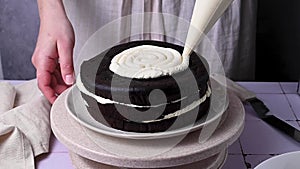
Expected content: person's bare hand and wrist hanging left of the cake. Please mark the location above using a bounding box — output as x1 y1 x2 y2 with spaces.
32 0 75 103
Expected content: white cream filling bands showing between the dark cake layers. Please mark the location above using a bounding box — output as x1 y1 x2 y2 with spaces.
76 74 211 123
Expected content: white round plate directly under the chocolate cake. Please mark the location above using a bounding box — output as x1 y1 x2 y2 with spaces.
65 79 229 139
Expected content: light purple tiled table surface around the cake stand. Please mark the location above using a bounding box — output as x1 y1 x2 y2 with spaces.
6 81 300 169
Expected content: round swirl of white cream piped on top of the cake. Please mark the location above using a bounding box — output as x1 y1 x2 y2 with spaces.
109 45 189 79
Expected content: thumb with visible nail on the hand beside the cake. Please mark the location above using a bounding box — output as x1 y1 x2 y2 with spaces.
57 39 75 85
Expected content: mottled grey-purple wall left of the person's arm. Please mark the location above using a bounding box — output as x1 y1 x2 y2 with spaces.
0 0 39 80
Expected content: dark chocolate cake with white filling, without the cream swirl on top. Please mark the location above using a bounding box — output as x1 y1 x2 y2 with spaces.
76 41 211 132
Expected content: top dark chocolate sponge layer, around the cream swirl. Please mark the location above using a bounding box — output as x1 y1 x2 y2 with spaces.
80 41 209 106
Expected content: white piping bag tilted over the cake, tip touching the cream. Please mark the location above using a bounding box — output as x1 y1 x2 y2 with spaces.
182 0 233 57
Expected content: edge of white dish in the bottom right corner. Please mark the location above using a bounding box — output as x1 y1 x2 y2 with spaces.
254 151 300 169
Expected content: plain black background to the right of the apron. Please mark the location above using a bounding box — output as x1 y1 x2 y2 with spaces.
255 0 300 81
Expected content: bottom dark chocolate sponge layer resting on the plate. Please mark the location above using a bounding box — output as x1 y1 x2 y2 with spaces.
82 94 210 133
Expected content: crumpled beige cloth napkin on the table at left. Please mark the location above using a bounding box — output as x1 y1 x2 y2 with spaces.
0 79 51 169
